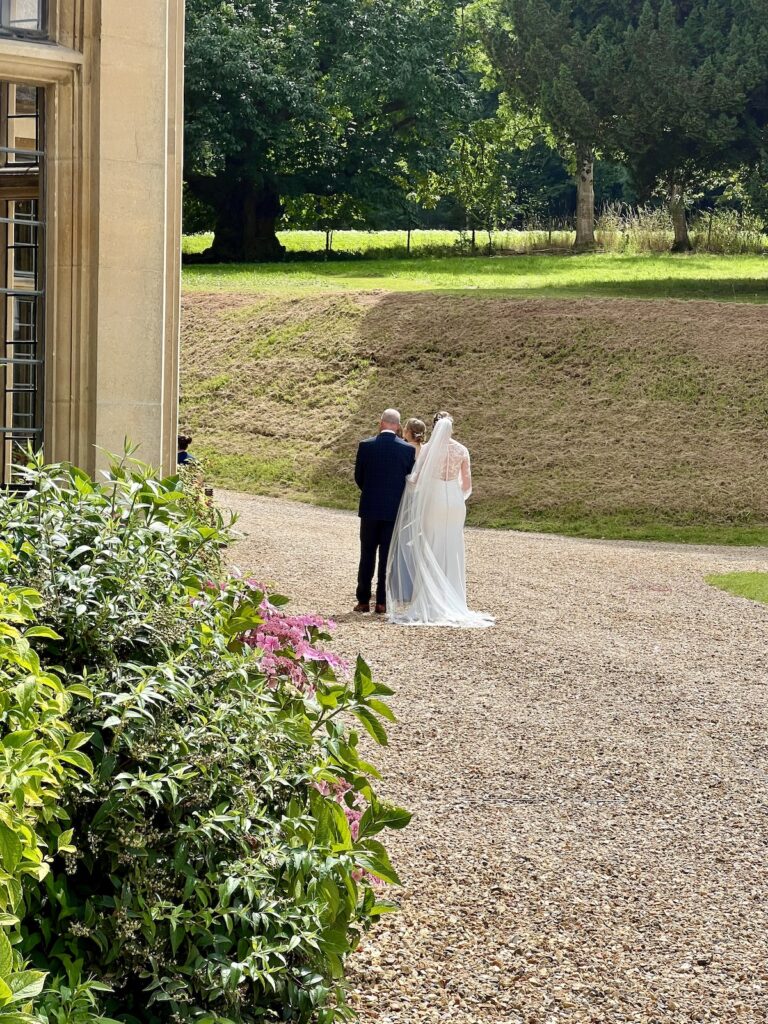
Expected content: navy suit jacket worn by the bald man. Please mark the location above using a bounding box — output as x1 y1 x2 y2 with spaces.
354 433 416 522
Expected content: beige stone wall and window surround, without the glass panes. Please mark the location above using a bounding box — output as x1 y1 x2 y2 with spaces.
0 0 183 470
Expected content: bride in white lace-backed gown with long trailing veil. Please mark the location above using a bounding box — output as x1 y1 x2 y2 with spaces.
387 413 494 629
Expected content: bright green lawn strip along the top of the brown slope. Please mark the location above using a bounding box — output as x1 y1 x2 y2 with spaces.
184 253 768 302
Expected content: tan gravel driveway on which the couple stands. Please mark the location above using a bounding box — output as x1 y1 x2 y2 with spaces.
224 494 768 1024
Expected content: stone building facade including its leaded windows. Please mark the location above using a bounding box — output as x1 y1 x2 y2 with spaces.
0 0 183 483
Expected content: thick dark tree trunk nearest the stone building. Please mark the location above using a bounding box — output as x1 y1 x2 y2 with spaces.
190 178 286 263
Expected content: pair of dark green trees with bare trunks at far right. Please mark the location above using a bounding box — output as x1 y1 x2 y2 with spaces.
484 0 768 249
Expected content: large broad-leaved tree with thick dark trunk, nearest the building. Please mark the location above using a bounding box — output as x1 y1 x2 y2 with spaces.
185 0 470 260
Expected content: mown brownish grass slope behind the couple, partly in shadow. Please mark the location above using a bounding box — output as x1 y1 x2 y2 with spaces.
181 291 768 543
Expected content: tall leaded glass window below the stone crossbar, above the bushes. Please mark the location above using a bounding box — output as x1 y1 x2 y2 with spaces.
0 82 45 486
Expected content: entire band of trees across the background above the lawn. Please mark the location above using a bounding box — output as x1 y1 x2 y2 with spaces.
185 0 768 260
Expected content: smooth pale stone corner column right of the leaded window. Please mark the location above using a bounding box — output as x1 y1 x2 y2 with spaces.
91 0 183 471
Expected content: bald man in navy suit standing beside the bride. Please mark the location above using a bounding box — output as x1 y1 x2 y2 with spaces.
354 409 416 614
